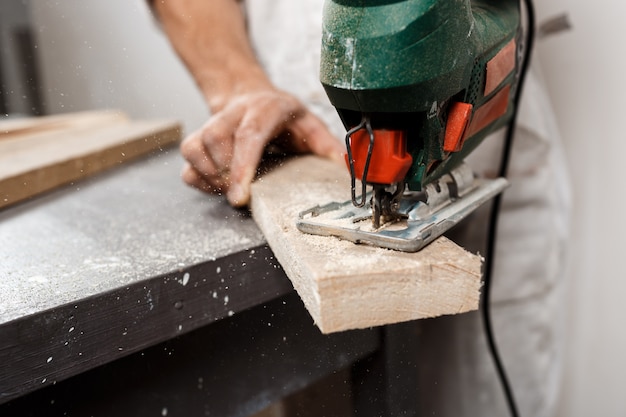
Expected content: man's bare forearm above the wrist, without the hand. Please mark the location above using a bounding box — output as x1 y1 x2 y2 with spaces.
154 0 270 112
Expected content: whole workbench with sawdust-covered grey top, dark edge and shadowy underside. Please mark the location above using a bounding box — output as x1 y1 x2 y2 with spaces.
0 148 417 417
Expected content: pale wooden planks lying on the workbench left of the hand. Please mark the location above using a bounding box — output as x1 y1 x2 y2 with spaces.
0 113 181 208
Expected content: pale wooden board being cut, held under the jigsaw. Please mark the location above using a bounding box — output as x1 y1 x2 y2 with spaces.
251 156 482 333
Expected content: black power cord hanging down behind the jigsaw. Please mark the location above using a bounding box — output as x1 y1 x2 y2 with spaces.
481 0 535 417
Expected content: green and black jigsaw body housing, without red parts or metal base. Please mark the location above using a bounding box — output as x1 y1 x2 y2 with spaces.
320 0 520 191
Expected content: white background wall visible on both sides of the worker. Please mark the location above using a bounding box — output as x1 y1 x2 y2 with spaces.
32 0 626 417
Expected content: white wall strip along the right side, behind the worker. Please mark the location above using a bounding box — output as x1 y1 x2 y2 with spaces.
536 0 626 417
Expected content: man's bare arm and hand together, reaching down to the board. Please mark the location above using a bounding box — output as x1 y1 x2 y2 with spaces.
154 0 343 206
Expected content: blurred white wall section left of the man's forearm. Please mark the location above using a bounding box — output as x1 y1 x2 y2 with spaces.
30 0 207 131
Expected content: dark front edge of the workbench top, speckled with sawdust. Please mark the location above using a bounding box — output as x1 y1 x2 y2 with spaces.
0 245 293 404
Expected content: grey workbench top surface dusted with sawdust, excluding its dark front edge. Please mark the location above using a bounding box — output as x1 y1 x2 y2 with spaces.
0 149 264 323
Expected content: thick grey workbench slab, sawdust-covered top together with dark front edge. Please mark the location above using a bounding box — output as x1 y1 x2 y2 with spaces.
0 148 293 403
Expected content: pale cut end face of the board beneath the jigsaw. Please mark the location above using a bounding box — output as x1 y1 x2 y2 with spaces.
318 244 482 333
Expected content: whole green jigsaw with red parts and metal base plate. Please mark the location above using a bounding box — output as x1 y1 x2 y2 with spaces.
297 0 521 252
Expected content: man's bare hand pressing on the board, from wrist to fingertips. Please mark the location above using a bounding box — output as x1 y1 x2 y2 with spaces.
181 89 343 207
